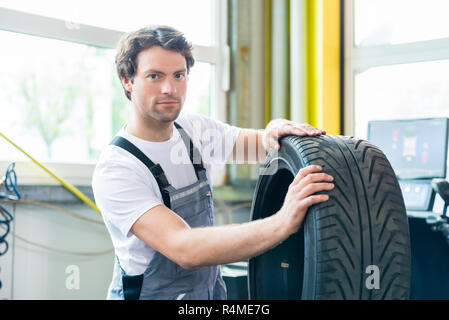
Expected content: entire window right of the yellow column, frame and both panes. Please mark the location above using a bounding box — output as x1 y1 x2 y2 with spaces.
344 0 449 138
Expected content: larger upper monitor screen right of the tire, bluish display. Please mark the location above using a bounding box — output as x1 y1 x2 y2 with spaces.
368 118 448 179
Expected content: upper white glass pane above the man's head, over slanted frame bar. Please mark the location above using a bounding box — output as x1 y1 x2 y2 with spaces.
0 0 213 46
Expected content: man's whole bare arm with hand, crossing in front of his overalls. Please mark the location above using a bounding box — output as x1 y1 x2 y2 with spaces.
131 166 333 269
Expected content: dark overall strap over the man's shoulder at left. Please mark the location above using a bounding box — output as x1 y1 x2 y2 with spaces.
110 136 170 208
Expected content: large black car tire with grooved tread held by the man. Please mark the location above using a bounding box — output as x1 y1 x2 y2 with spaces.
248 135 411 300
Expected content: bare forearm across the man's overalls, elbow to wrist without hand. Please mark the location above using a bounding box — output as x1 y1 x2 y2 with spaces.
173 216 287 268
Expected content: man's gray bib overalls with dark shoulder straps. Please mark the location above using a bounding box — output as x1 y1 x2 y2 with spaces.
108 122 226 300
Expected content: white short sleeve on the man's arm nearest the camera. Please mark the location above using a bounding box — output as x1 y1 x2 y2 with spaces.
92 160 163 237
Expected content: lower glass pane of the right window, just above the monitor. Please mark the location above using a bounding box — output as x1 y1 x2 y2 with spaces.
355 60 449 138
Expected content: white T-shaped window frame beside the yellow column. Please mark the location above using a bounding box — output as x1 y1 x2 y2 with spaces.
344 0 449 135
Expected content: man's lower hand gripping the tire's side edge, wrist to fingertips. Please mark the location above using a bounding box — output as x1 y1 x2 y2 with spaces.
277 165 334 237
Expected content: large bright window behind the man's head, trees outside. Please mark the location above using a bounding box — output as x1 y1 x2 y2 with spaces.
0 0 227 183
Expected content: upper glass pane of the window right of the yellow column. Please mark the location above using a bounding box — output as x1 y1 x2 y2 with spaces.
354 0 449 46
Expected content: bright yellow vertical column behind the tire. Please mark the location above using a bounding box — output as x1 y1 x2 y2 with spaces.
304 0 340 134
